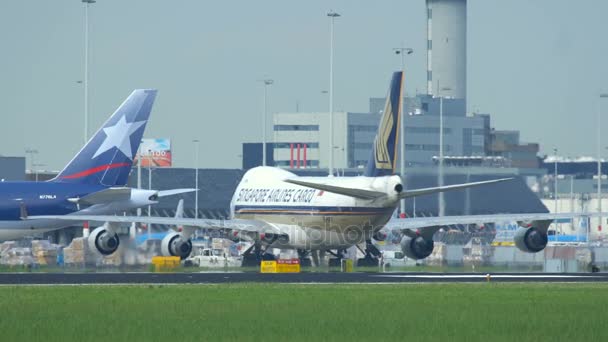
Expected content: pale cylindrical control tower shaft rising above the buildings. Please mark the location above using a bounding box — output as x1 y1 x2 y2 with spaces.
426 0 467 99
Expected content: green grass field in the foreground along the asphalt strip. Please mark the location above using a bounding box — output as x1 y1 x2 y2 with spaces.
0 283 608 342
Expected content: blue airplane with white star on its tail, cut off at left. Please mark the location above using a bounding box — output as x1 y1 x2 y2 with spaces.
0 89 194 254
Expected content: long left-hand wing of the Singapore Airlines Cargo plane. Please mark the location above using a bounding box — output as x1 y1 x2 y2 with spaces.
27 214 280 233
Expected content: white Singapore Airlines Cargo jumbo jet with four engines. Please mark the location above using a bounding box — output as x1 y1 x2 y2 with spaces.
32 72 592 264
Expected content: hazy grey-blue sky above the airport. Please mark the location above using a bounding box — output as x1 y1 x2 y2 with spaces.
0 0 608 169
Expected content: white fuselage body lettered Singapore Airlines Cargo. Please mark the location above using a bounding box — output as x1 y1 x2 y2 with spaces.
231 167 400 249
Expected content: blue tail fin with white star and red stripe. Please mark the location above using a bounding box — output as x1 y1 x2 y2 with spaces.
51 89 156 186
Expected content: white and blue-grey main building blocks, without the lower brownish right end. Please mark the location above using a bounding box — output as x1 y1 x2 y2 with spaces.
273 106 489 169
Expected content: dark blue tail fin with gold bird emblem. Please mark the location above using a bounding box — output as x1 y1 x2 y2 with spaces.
364 71 403 177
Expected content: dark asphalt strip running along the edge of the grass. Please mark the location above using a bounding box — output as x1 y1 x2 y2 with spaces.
0 272 608 285
